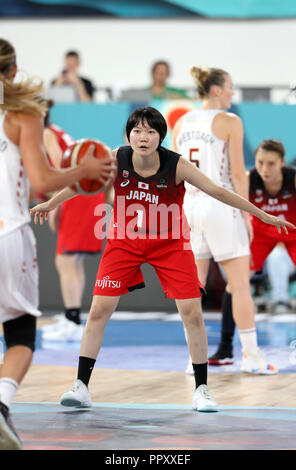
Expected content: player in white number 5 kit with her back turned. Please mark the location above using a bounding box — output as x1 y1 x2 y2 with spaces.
173 67 277 374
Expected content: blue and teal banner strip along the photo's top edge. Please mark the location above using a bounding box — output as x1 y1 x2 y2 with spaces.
0 0 296 18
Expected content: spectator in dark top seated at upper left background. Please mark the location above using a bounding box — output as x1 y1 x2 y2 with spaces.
51 51 95 102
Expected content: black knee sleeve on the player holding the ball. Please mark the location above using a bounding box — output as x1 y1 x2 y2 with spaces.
3 314 36 352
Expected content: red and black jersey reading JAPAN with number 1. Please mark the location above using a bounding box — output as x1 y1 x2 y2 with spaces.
108 146 190 239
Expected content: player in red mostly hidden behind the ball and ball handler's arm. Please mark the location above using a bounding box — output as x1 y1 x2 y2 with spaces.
42 101 105 341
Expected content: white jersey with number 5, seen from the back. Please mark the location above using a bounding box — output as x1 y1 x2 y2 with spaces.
176 109 234 194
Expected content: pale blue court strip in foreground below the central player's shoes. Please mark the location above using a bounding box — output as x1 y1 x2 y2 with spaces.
12 403 296 452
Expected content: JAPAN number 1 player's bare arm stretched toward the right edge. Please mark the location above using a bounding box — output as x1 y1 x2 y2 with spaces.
176 158 296 233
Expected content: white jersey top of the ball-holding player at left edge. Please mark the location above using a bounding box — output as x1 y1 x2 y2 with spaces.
0 114 30 237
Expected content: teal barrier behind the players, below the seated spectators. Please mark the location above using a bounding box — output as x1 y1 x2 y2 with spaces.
51 101 296 168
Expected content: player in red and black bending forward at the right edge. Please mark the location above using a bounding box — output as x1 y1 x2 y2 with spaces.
209 139 296 365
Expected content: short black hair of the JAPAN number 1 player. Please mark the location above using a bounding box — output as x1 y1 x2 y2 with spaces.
125 106 167 145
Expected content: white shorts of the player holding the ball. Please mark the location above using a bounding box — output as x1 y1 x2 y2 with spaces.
0 225 41 323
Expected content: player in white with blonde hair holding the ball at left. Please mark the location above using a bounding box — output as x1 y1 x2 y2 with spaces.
0 39 113 450
